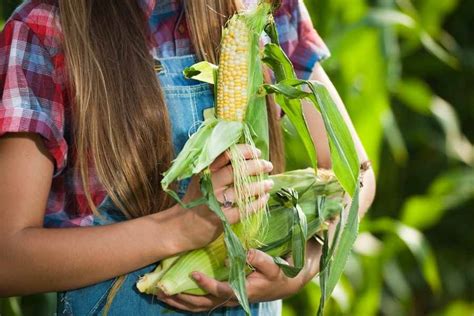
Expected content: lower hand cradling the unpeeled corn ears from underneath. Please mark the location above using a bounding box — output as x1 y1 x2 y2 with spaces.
158 241 321 312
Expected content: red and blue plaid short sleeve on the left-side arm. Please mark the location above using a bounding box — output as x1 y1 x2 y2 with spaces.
0 20 67 176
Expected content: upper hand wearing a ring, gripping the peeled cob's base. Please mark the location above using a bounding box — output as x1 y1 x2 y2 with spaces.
178 144 273 250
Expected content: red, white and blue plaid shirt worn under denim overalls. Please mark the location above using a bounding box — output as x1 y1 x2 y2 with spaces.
0 0 329 227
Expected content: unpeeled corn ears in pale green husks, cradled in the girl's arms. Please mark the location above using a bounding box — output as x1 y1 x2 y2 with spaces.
137 168 343 295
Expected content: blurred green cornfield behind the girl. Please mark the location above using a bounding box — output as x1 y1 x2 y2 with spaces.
0 0 474 316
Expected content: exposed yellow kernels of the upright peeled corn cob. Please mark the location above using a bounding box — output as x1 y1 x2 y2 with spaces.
217 16 249 122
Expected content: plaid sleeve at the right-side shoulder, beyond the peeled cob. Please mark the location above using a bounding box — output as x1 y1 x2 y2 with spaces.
275 0 331 79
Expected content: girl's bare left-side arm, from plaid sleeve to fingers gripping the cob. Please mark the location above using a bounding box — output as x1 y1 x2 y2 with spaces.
0 133 269 297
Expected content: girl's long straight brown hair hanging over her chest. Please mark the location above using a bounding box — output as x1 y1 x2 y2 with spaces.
59 0 284 218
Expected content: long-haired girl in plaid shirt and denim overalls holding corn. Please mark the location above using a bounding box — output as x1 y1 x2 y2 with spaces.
0 0 374 315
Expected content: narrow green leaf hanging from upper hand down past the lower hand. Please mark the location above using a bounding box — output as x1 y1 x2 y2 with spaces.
201 173 250 315
